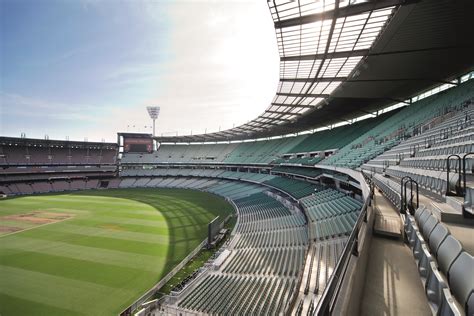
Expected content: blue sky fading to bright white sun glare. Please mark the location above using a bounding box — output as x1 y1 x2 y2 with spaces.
0 0 279 141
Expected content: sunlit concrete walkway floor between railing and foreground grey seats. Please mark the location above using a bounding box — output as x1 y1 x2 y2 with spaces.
360 236 431 316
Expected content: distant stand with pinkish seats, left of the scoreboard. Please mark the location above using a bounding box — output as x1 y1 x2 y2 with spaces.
0 137 118 195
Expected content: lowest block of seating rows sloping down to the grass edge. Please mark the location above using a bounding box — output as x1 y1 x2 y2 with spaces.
178 190 308 315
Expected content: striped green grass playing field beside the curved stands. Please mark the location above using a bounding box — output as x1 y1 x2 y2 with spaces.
0 189 232 316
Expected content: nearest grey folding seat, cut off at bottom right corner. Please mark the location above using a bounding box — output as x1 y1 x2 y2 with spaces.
449 251 474 315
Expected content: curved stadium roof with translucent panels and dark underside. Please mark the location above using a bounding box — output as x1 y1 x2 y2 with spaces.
156 0 474 142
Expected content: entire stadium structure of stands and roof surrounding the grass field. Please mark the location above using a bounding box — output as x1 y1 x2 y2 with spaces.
0 0 474 315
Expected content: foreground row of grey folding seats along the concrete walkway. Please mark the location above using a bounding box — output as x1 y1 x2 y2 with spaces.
404 206 474 315
